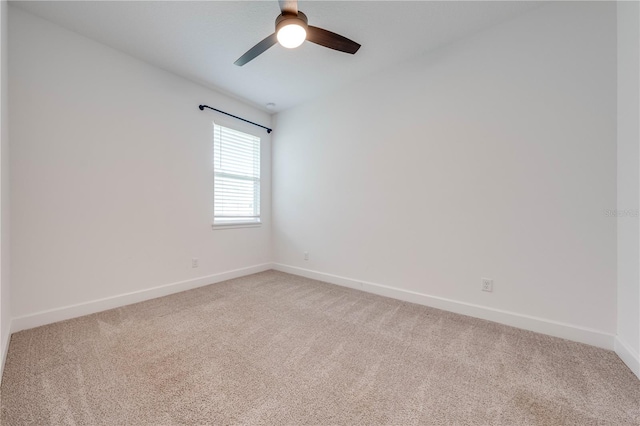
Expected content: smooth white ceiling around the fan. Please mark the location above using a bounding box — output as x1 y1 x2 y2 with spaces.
11 0 539 111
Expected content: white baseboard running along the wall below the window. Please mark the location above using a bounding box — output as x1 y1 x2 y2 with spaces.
7 263 272 332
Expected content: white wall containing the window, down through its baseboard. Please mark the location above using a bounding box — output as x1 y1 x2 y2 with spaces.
9 7 271 329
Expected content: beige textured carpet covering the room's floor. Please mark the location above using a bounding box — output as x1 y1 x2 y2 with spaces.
1 271 640 426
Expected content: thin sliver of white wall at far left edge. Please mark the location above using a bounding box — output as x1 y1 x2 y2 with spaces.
0 0 11 380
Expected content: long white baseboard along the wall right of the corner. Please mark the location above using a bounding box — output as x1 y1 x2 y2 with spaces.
273 263 615 350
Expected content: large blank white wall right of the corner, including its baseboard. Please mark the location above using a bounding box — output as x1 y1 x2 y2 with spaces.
273 2 616 348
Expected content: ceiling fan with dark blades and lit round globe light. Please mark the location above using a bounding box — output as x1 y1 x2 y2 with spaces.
234 0 360 67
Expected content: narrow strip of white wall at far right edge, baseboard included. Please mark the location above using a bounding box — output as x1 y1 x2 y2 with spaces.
616 2 640 376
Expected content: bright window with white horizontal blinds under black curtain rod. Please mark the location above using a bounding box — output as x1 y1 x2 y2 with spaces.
213 124 260 226
